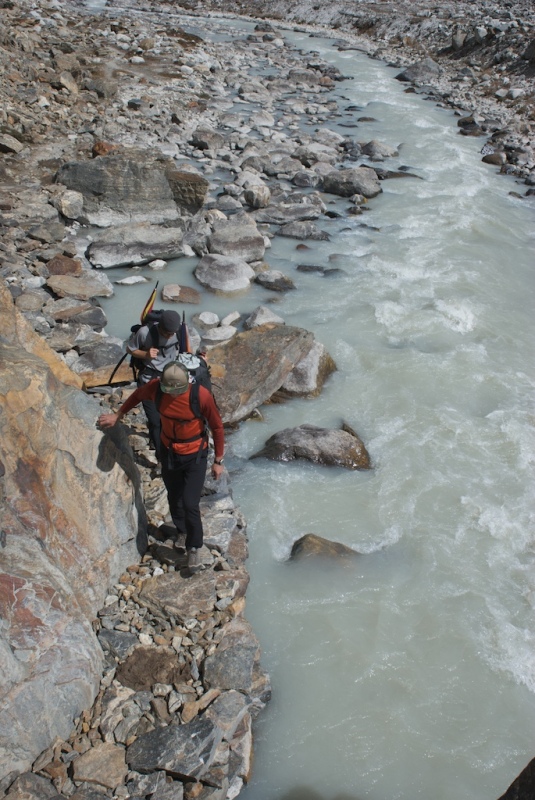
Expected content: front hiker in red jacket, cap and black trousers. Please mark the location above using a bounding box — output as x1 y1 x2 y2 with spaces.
98 362 225 573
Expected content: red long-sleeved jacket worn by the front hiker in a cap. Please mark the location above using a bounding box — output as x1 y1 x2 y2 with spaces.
121 378 225 458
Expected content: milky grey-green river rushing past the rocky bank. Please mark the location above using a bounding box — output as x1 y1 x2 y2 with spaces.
94 7 535 800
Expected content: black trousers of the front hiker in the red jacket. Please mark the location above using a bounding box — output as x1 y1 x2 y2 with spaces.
161 443 208 550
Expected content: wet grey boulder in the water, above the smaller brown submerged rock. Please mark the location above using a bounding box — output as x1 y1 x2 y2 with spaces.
252 424 370 469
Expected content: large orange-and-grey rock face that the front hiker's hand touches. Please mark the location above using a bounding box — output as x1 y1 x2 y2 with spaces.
0 287 144 776
